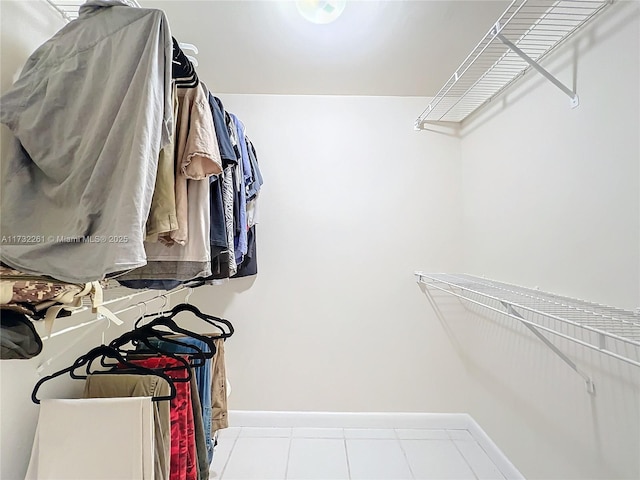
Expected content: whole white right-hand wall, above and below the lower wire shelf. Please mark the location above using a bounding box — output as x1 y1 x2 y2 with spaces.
456 2 640 479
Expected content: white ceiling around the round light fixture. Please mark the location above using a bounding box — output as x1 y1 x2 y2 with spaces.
140 0 510 96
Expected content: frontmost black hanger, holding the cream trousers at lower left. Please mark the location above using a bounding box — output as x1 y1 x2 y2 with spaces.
31 345 176 404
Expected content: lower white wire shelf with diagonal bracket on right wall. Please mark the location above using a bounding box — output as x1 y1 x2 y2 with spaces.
415 272 640 393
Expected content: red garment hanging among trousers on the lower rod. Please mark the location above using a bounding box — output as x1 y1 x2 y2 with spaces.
123 357 198 480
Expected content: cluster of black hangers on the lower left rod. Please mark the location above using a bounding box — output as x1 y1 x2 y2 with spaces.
31 303 234 404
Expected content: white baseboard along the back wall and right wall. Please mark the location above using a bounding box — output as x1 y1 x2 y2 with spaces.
229 410 524 480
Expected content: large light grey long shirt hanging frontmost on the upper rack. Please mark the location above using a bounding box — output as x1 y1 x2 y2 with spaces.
0 0 173 283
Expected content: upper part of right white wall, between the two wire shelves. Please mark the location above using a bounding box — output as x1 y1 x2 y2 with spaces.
461 1 640 309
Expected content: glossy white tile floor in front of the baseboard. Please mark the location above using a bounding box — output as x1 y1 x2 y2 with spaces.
210 427 505 480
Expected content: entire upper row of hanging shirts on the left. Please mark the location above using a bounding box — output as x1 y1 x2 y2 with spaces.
0 0 262 288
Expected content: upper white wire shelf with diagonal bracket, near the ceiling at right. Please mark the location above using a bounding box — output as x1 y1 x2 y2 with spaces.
414 0 613 130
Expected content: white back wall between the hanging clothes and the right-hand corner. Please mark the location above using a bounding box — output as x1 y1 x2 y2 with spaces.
193 94 464 412
